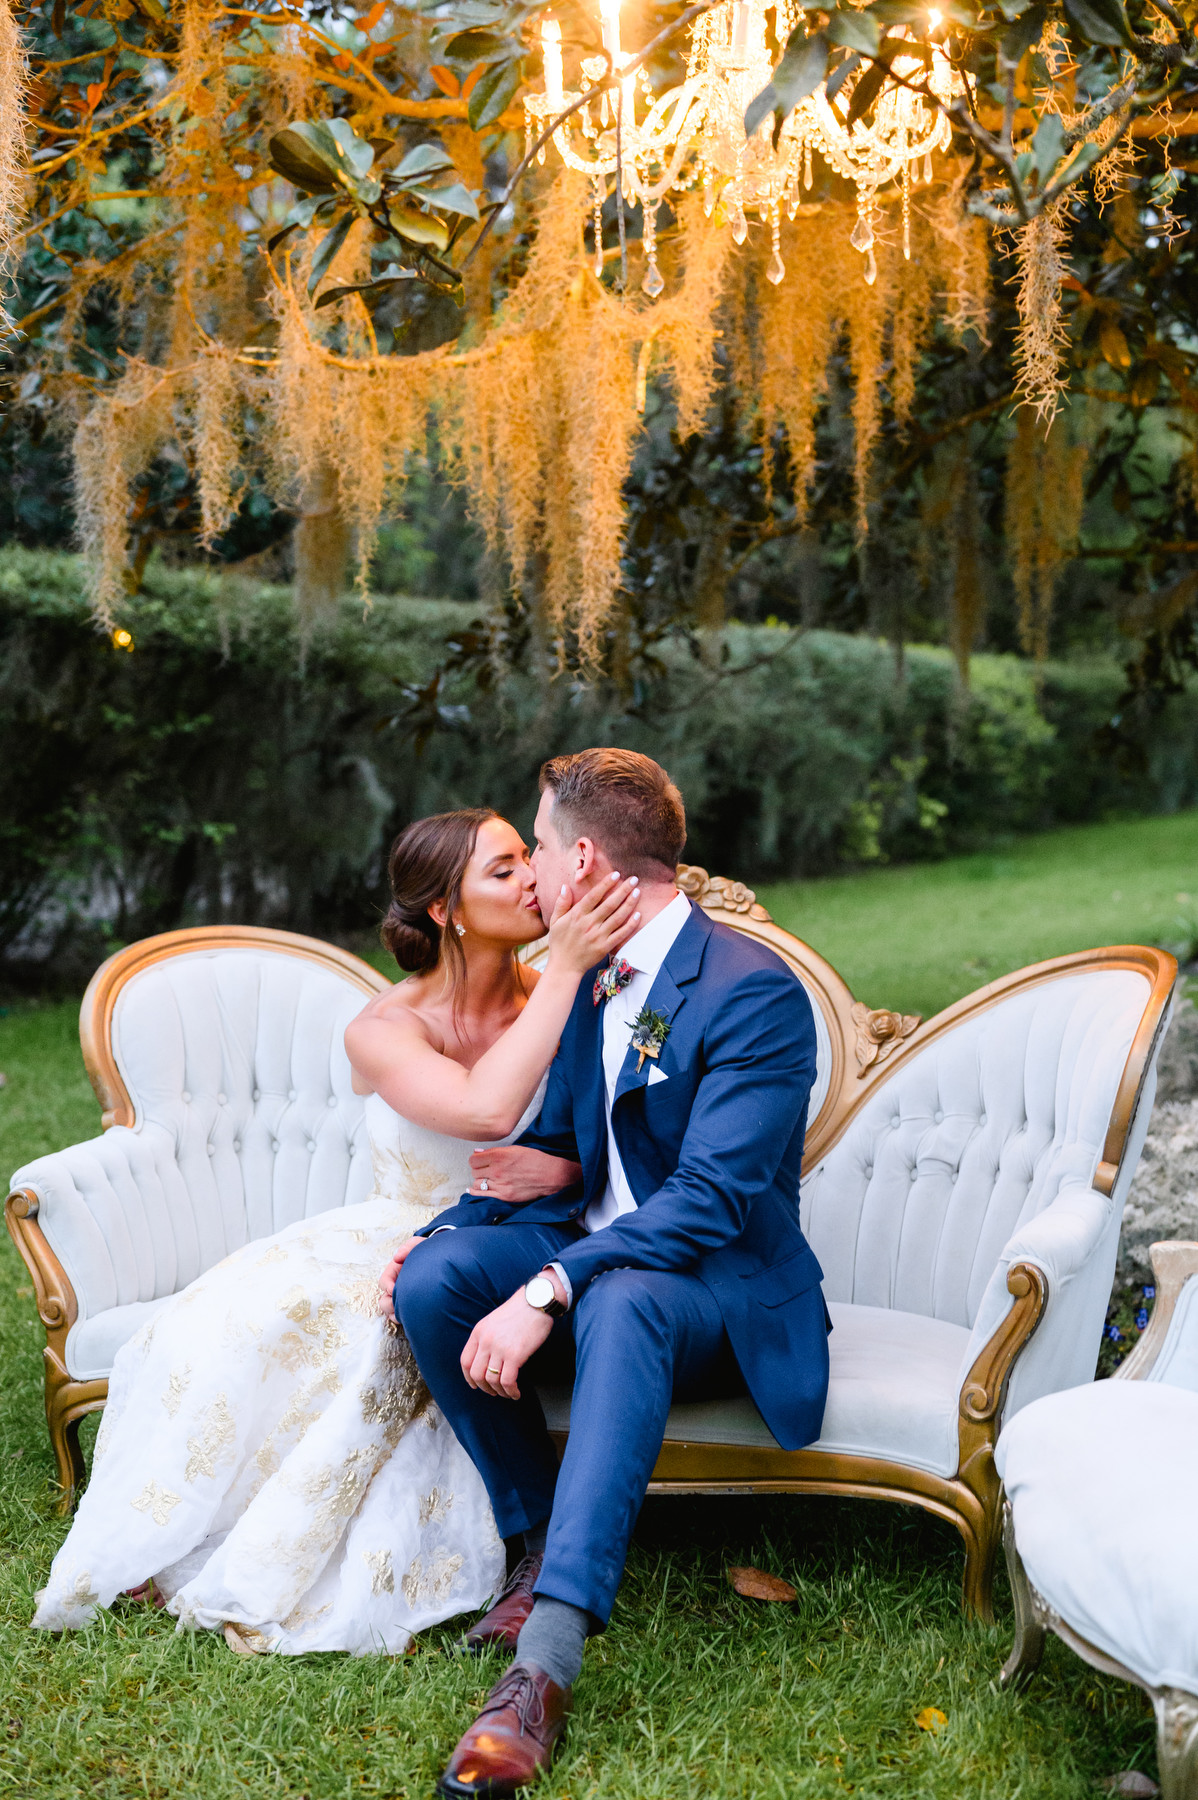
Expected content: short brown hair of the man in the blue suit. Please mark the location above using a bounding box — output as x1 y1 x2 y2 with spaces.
541 749 687 880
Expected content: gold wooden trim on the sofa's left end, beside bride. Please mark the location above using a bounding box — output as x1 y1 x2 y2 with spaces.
4 925 390 1512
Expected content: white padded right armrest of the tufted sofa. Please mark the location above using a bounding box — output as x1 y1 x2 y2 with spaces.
961 1184 1119 1418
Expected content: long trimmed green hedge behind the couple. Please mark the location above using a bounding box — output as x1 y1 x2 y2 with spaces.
0 547 1198 963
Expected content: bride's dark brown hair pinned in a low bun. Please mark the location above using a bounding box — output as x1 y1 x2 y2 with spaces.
380 806 498 981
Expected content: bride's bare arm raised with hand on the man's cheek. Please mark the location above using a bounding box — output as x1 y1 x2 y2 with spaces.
345 878 640 1141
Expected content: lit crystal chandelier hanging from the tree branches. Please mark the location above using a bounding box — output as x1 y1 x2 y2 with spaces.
523 0 964 297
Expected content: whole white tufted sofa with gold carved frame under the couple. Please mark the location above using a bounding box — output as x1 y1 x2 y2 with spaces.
7 892 1176 1615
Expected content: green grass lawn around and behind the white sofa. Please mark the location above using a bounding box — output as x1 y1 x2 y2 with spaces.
0 814 1198 1800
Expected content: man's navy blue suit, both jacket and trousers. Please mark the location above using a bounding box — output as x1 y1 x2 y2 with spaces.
396 907 827 1625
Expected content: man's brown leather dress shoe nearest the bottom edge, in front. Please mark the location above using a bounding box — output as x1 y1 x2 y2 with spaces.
437 1663 570 1800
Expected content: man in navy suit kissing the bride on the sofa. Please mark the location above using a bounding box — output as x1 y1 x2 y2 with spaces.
394 749 827 1796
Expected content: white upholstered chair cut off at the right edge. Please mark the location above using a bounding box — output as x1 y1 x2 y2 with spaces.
997 1242 1198 1800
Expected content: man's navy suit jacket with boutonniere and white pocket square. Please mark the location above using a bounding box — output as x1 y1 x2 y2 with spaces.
426 907 829 1449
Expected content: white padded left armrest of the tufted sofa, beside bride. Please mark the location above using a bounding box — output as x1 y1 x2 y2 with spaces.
9 1125 200 1318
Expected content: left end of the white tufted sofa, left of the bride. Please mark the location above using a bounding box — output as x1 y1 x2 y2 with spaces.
7 927 387 1499
